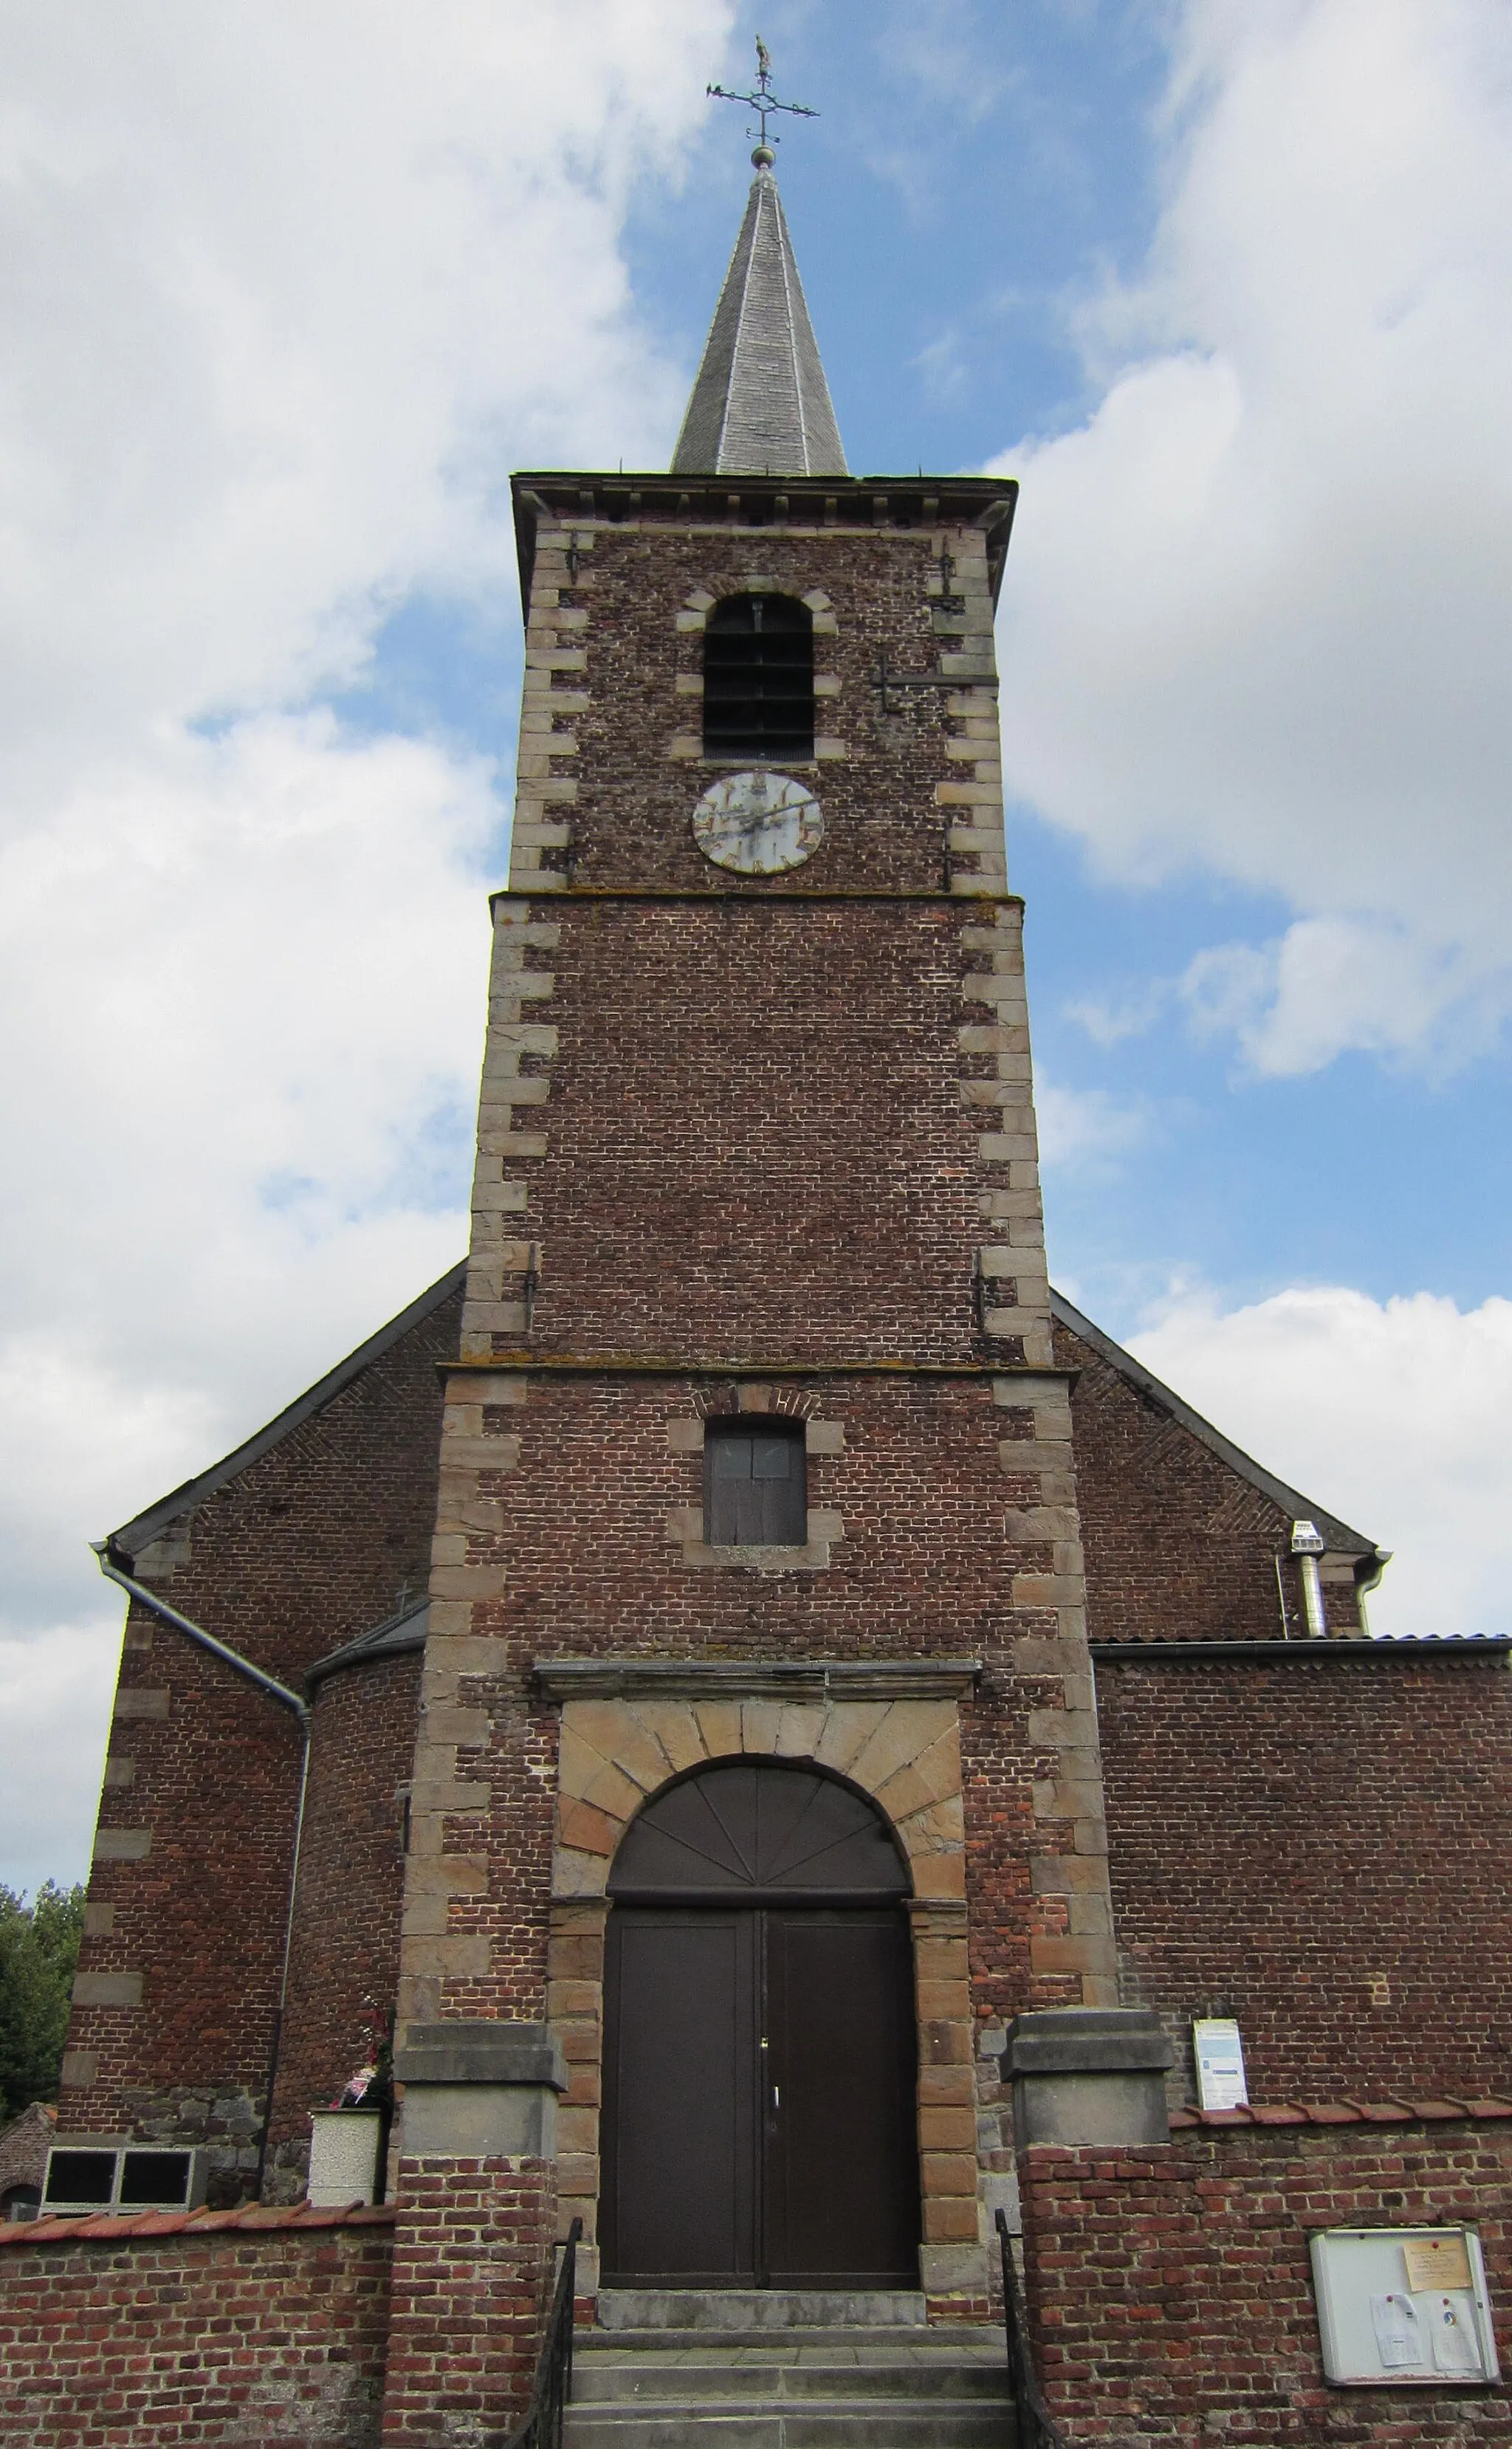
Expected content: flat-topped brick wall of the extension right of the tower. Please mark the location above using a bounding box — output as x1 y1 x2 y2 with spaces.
1098 1651 1512 2099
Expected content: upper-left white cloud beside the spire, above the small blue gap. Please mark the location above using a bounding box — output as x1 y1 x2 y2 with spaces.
0 0 728 772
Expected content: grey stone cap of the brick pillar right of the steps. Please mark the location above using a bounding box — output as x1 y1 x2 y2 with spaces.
1003 2006 1174 2150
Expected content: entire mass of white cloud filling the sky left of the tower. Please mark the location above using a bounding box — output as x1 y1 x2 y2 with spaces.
0 0 732 1883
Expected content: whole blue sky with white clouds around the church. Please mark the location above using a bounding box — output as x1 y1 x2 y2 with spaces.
0 0 1512 1888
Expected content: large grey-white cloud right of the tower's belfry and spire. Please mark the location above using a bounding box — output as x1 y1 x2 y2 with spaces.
997 0 1512 1071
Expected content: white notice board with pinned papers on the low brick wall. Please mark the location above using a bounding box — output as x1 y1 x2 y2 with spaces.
1311 2228 1497 2390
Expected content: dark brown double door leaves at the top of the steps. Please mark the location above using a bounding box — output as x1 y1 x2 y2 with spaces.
600 1790 919 2287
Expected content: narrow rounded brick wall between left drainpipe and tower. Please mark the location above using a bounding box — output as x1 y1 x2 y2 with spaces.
264 1651 419 2202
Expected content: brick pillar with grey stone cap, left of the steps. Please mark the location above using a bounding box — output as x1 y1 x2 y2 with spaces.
382 2023 566 2449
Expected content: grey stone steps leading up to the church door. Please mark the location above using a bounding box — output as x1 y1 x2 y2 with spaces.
566 2287 1014 2449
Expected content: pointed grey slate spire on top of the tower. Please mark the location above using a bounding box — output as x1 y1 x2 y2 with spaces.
671 169 848 475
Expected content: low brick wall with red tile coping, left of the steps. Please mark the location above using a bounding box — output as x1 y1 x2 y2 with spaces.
0 2209 392 2449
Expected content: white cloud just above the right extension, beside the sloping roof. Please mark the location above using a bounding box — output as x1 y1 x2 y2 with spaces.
1130 1285 1512 1633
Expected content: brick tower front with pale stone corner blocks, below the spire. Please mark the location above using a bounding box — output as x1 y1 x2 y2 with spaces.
389 478 1115 2370
